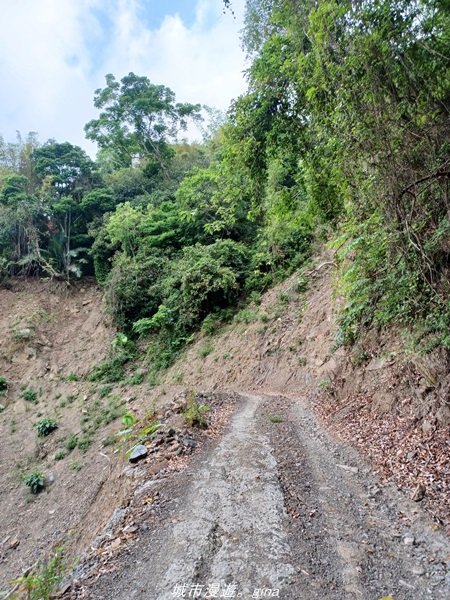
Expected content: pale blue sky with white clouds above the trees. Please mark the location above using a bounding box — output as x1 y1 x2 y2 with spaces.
0 0 245 154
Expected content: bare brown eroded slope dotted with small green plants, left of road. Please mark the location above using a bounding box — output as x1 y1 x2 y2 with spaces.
0 280 131 588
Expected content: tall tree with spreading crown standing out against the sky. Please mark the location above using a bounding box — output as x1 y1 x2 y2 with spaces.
85 73 200 174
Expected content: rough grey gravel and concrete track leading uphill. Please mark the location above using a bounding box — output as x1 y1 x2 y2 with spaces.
82 395 450 600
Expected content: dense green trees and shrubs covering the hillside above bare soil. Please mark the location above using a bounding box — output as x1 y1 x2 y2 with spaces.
0 0 450 381
